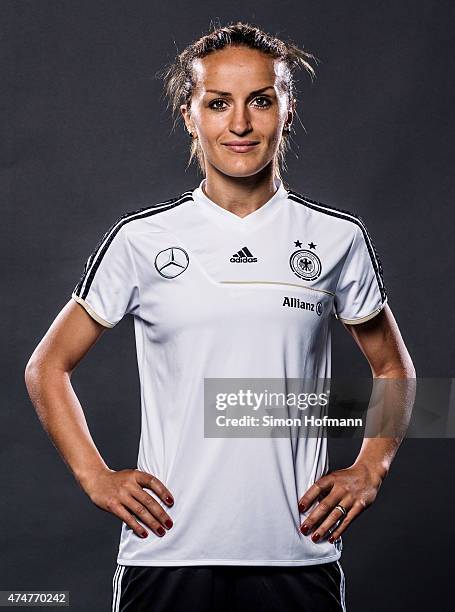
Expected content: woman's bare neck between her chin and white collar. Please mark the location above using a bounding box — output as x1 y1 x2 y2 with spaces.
204 164 276 217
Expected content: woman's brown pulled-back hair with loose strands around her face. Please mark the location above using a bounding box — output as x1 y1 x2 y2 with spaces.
158 21 318 178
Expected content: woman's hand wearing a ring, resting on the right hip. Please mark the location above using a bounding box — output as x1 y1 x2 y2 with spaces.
299 463 383 542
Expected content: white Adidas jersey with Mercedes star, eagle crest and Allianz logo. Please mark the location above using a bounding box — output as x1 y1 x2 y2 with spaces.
72 179 387 566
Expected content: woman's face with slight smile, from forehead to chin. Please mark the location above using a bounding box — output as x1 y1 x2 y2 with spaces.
180 47 293 177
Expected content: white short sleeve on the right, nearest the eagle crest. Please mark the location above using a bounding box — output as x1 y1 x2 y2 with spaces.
334 218 387 325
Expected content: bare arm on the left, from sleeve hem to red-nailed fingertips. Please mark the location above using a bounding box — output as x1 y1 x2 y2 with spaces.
25 299 173 537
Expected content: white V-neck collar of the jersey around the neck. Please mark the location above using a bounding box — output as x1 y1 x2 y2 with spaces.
192 178 288 230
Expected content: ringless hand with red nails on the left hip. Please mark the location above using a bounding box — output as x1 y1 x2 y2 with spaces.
81 468 174 538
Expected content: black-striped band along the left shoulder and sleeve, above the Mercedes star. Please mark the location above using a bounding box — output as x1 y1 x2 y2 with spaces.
73 191 193 299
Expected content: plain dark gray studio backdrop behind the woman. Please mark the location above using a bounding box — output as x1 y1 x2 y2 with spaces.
0 0 455 612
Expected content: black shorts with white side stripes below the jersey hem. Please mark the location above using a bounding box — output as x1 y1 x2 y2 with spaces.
112 561 346 612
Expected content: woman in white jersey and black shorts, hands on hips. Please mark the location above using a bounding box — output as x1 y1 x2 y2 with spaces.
26 23 414 612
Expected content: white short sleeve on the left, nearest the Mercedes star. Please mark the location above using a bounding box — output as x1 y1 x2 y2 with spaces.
71 218 139 327
